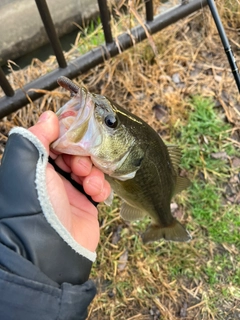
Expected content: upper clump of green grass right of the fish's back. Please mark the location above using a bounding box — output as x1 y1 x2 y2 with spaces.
177 97 236 176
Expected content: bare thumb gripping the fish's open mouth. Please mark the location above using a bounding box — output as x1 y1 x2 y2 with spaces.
28 111 59 152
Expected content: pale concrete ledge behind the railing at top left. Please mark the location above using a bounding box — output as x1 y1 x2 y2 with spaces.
0 0 98 65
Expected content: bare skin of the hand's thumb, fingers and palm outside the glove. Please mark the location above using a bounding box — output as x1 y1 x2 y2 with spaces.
29 111 111 252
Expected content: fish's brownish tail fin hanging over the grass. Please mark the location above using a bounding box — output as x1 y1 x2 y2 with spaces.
142 219 192 243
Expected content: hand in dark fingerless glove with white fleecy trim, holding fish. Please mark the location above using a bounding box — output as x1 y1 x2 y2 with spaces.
0 111 111 284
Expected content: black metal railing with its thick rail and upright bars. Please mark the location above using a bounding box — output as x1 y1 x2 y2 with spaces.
0 0 237 118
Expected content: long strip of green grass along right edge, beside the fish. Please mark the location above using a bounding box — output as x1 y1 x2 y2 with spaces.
174 97 240 245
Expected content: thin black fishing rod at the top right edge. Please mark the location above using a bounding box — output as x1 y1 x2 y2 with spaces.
207 0 240 93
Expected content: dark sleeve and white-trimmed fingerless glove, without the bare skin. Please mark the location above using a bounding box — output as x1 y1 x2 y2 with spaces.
0 129 96 320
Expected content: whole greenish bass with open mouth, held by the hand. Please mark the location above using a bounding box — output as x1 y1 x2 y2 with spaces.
51 77 191 243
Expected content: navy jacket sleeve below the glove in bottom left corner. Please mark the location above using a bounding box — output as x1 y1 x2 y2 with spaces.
0 244 96 320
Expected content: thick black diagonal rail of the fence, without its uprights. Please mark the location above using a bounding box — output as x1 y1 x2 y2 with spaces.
0 0 207 118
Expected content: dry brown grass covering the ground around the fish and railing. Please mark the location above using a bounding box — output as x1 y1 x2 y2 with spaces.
0 1 240 320
